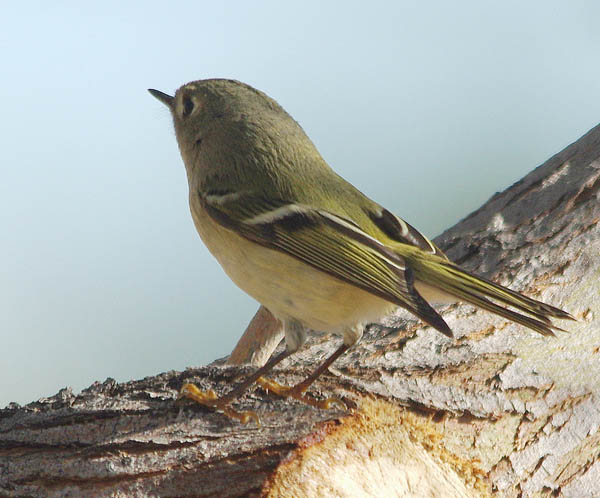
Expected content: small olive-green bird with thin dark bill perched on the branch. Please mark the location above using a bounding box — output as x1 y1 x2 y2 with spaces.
150 79 571 420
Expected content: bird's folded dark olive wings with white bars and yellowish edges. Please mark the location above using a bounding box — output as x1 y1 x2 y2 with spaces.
198 192 452 336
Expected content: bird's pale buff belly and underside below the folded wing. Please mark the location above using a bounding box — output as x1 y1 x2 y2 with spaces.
190 197 452 336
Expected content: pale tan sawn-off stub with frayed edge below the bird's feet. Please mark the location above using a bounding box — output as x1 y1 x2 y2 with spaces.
263 398 490 497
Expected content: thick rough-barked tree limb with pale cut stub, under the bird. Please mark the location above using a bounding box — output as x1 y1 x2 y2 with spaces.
0 127 600 497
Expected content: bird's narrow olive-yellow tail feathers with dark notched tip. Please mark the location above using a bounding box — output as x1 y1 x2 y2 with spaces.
410 257 574 335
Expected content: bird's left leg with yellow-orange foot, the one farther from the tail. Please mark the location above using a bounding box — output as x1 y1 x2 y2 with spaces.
179 349 292 424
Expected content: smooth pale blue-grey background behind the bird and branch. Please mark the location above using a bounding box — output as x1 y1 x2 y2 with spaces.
0 0 600 407
